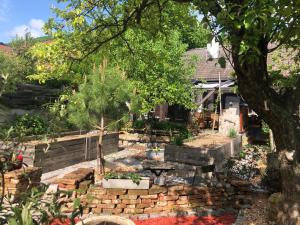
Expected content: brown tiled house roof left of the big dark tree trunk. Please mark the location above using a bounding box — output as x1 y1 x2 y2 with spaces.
185 48 234 81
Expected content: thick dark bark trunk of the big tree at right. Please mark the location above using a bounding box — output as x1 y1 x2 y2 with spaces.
232 38 300 225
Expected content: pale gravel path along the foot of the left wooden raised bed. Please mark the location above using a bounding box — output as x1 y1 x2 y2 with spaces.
42 149 140 184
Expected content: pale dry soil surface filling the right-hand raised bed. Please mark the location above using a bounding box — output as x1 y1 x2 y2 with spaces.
184 133 231 148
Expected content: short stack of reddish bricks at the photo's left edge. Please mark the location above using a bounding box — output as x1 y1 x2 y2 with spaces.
0 167 42 199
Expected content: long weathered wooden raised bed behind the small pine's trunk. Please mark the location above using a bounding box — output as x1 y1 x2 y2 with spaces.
23 133 119 173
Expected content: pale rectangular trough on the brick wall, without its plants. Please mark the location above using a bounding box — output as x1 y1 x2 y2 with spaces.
102 177 150 190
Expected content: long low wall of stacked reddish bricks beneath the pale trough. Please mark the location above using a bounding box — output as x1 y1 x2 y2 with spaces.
58 179 251 216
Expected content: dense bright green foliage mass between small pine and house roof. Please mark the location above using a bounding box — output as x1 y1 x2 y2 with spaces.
109 29 194 113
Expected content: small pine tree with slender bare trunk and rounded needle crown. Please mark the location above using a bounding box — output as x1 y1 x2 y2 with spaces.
67 60 134 179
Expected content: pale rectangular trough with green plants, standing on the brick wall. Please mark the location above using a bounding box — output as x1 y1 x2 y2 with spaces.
102 172 150 189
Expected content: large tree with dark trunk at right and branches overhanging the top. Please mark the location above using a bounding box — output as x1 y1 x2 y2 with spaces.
37 0 300 224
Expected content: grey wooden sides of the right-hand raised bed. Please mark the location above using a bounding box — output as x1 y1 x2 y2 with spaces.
165 136 241 171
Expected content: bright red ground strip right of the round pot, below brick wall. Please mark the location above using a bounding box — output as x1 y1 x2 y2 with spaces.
134 215 235 225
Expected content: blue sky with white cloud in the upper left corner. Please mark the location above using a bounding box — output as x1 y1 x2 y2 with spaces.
0 0 57 43
